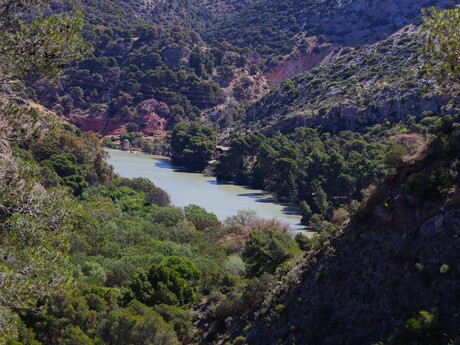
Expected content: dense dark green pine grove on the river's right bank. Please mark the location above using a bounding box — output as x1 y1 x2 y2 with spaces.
215 128 388 223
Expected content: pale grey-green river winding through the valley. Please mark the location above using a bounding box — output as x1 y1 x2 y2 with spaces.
107 150 303 230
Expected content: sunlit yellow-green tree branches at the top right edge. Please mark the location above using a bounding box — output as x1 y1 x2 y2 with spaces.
422 7 460 91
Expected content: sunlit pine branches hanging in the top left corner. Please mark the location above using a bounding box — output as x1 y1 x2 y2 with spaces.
0 0 89 84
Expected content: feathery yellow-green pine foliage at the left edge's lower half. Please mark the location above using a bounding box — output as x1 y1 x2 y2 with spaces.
0 161 76 334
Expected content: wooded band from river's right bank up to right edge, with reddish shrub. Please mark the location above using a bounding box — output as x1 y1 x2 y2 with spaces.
215 112 458 229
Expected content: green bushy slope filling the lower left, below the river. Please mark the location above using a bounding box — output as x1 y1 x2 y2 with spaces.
0 1 300 344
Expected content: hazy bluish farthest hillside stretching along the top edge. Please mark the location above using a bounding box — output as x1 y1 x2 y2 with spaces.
76 0 460 71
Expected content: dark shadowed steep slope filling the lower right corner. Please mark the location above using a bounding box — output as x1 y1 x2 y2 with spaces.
234 124 460 345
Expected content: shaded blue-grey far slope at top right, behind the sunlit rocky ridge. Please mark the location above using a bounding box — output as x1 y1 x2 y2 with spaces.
204 0 458 54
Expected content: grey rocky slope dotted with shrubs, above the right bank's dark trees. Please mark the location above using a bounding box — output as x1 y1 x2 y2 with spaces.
246 26 456 133
